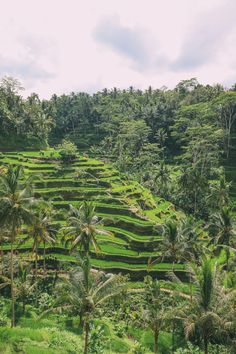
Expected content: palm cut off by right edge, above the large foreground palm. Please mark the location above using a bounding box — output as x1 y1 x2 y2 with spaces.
210 207 236 270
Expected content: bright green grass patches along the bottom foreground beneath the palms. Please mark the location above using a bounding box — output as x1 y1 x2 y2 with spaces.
0 314 171 354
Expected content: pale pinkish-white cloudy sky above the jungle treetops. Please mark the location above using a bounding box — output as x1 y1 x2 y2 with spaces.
0 0 236 97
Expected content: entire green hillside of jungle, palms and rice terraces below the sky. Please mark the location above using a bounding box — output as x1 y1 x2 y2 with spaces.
0 77 236 354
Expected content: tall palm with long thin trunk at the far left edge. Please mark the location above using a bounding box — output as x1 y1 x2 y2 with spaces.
0 166 34 327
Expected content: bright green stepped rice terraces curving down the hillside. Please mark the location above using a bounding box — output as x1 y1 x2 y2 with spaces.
0 150 184 279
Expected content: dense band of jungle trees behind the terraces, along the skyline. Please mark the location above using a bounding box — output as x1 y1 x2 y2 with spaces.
0 77 236 157
